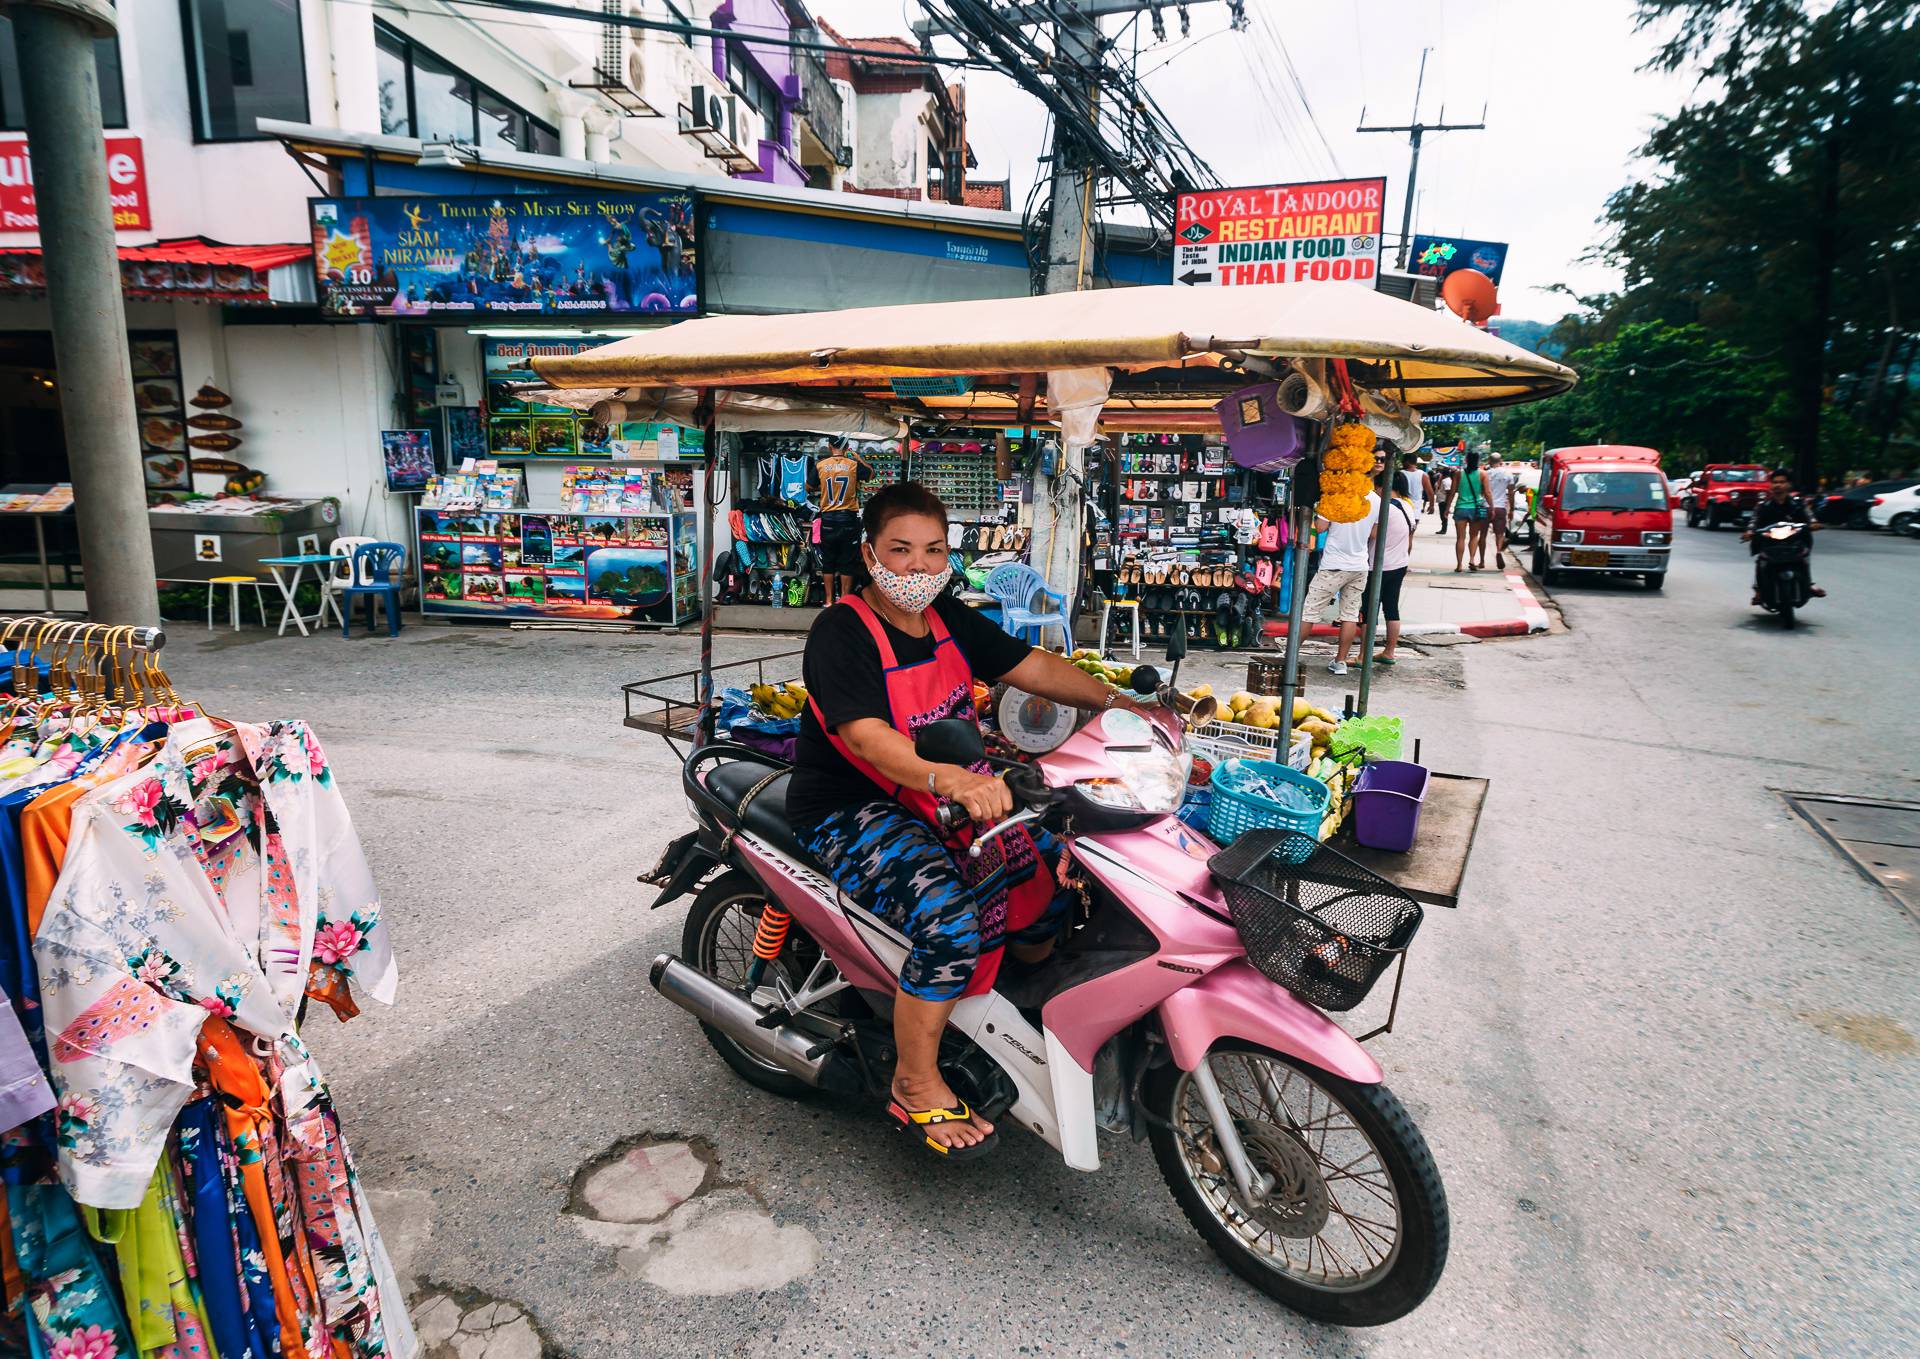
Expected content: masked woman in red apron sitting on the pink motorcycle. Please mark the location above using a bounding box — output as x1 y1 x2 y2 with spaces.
787 482 1133 1159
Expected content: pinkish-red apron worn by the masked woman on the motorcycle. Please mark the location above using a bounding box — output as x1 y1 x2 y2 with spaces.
806 595 1054 996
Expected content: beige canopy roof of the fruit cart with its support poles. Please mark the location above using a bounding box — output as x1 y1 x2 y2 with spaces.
532 282 1574 771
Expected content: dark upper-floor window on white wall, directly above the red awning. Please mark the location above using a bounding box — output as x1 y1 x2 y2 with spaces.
182 0 307 142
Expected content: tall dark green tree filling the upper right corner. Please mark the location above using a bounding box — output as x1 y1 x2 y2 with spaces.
1576 0 1920 484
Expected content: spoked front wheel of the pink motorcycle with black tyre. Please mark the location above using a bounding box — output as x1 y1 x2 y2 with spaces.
1146 1042 1452 1326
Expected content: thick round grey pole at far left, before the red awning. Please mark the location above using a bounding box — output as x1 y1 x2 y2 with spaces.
0 0 159 628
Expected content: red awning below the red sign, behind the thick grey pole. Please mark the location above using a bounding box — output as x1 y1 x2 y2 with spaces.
0 236 313 305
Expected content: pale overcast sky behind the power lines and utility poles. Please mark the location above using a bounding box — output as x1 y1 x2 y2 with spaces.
812 0 1692 321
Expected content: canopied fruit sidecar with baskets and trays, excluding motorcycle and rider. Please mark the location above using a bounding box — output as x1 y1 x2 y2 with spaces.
532 282 1576 990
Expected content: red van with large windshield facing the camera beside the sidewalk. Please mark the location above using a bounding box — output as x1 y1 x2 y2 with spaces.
1532 443 1674 589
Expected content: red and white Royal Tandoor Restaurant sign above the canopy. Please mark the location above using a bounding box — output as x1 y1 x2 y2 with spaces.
1173 179 1386 288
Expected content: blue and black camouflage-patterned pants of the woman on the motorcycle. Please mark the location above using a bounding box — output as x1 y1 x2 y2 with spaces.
797 799 1068 1000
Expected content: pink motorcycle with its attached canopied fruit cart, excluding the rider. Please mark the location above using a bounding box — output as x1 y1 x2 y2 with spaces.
536 284 1574 1324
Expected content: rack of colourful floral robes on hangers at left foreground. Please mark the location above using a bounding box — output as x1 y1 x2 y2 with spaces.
0 618 417 1359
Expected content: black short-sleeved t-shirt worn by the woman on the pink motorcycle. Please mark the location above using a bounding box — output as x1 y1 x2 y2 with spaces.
787 595 1033 829
